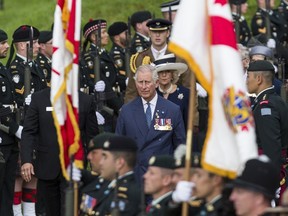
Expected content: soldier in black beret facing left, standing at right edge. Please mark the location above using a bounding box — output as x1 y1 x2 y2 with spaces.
246 60 288 198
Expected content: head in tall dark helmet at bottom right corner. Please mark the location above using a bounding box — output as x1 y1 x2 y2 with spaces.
230 155 279 216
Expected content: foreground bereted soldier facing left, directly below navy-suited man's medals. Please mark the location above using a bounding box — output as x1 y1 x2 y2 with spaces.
143 155 175 216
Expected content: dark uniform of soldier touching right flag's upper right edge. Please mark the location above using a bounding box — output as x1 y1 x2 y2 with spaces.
232 13 251 46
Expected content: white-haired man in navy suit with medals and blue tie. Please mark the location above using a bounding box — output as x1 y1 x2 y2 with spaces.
116 65 186 181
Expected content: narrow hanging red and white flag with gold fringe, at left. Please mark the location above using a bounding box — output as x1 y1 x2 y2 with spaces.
50 0 84 180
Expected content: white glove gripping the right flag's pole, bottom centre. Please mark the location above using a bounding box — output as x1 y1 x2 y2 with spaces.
172 181 195 203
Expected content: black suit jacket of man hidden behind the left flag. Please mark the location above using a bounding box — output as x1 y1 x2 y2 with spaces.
21 89 98 180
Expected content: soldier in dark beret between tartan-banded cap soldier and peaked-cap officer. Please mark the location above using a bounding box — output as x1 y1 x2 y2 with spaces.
108 22 129 93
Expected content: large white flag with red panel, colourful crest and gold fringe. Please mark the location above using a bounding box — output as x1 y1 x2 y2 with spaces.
169 0 257 178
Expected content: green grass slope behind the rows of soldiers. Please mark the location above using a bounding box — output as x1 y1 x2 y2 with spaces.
0 0 280 63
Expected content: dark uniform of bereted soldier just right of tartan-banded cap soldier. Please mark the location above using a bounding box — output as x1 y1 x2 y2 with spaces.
110 43 127 92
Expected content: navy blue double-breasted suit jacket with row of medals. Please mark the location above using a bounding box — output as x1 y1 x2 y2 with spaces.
116 96 186 177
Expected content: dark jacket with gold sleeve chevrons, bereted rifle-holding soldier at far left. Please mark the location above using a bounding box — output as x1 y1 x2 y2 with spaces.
10 56 47 106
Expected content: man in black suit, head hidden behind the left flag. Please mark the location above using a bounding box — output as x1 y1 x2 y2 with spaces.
21 89 98 216
